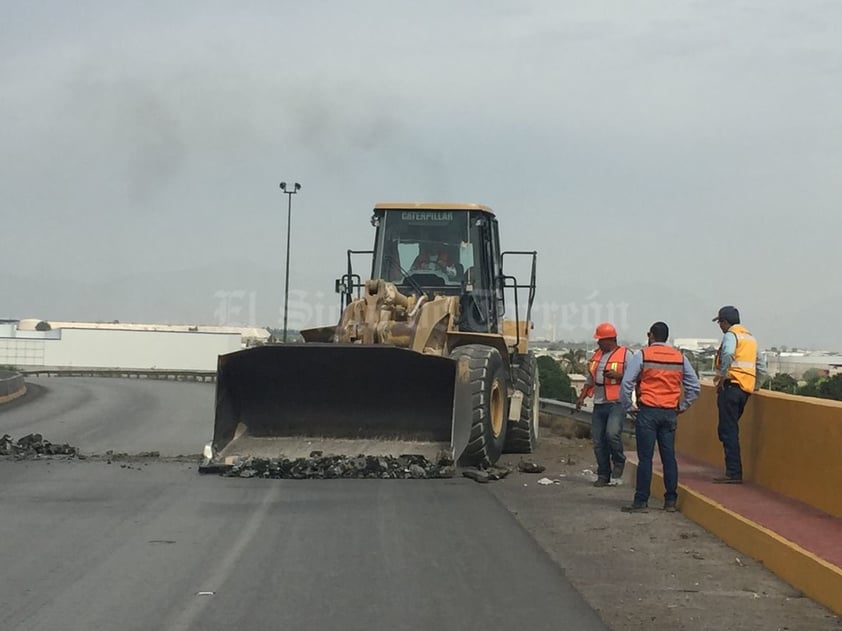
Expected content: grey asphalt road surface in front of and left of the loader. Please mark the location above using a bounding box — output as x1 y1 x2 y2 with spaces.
0 378 605 631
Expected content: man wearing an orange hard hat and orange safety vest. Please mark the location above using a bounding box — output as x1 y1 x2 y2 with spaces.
576 322 628 486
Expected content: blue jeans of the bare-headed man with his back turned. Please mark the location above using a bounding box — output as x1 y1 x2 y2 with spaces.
634 405 678 504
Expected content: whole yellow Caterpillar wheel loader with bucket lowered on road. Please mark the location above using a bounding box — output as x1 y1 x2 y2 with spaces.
205 203 539 466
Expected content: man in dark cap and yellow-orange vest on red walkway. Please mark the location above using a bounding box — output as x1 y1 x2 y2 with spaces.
713 305 766 484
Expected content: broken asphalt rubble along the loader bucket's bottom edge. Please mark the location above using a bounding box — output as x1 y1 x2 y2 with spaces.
199 451 456 480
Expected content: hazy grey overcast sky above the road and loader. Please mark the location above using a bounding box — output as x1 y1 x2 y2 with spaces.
0 0 842 350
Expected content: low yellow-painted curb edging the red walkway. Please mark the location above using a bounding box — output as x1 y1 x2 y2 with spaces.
623 458 842 614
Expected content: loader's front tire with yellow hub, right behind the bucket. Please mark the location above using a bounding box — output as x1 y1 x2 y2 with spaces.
451 344 509 467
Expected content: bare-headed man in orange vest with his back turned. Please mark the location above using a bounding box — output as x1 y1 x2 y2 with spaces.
620 322 701 513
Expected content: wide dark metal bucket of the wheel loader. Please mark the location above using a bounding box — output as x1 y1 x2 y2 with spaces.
212 343 471 460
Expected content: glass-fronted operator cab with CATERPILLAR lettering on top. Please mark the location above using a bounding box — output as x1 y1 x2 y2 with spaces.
371 204 504 333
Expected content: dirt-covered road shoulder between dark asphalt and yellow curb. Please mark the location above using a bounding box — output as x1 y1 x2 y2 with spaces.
489 424 842 631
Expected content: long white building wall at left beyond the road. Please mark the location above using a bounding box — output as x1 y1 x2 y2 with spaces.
0 329 241 370
